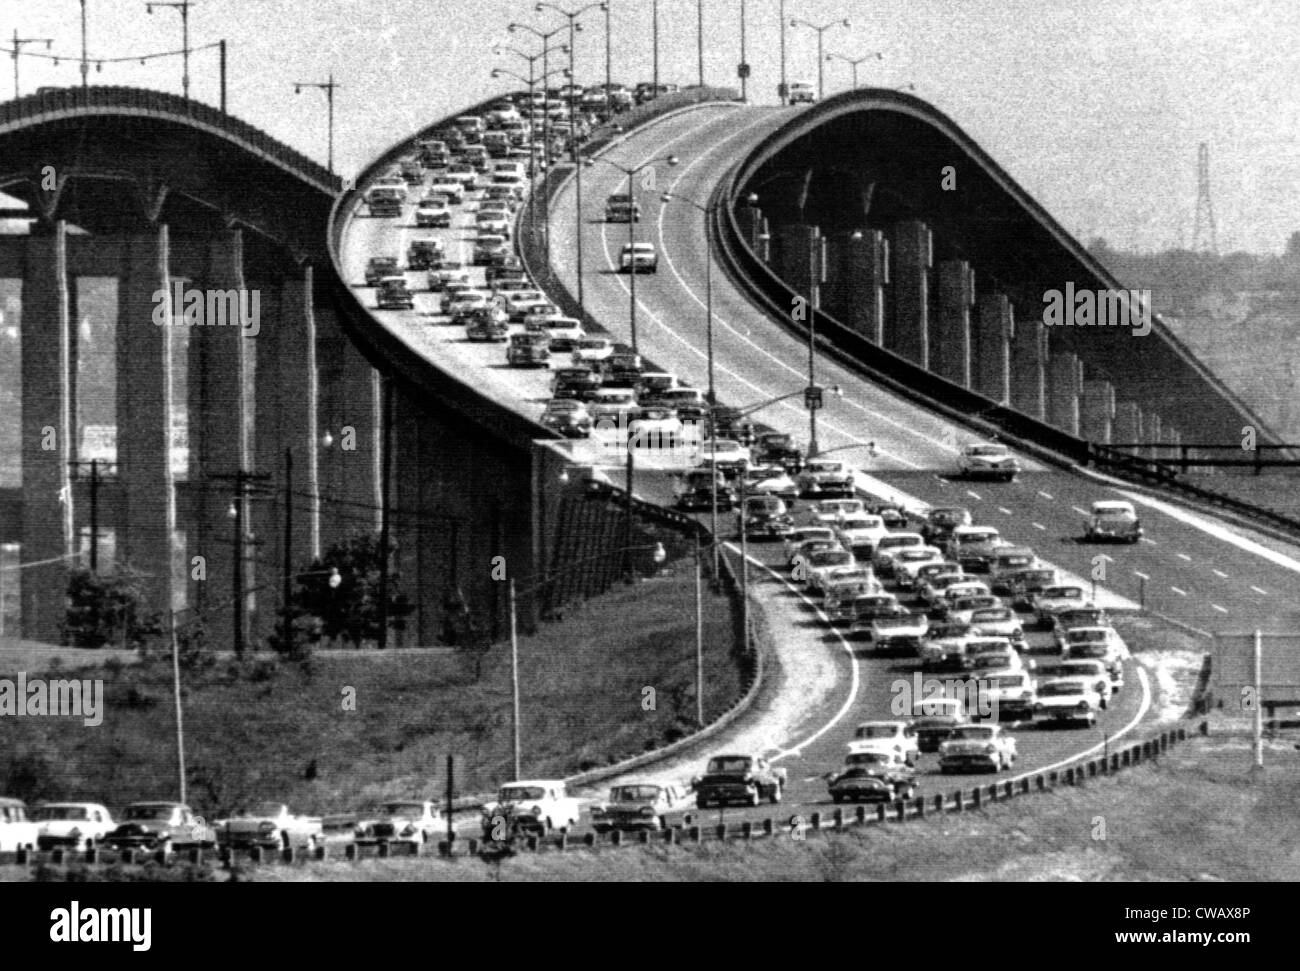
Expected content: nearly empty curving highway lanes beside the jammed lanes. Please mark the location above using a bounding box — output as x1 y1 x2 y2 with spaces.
554 108 1300 630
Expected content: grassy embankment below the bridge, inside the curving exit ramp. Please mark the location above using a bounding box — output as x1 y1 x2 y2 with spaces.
0 563 741 816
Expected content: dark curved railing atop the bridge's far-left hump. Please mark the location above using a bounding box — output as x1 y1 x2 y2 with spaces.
0 86 342 191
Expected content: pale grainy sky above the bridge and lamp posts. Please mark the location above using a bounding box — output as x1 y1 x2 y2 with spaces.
0 0 1300 253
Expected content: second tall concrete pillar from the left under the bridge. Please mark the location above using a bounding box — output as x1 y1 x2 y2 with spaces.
117 230 183 611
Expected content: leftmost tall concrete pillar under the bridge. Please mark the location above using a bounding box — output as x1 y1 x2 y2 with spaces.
21 220 75 643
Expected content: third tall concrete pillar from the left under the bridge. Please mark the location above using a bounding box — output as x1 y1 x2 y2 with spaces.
187 230 253 650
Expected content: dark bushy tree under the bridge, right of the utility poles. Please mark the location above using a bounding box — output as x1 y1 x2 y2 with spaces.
293 534 415 647
